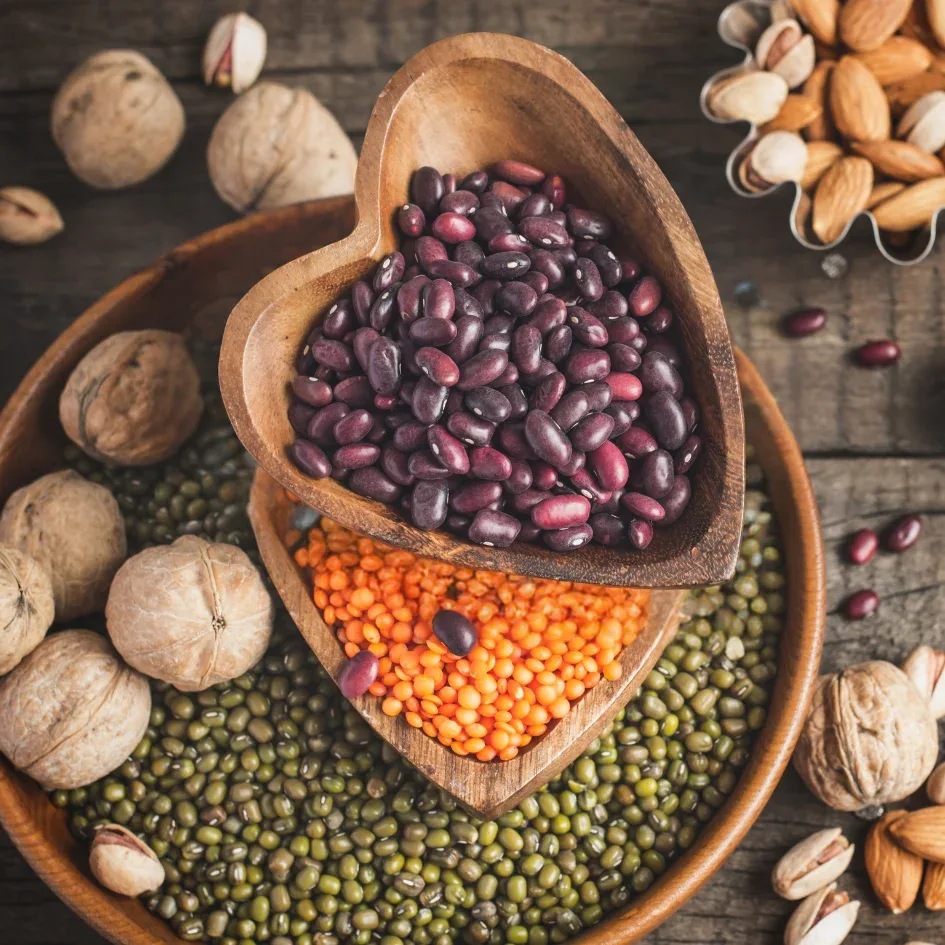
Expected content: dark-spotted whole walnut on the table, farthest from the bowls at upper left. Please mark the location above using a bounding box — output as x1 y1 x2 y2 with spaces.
52 49 184 190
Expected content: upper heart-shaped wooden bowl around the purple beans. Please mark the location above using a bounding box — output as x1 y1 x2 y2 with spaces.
220 33 744 587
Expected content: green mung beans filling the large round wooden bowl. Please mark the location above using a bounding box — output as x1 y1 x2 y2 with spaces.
51 352 785 945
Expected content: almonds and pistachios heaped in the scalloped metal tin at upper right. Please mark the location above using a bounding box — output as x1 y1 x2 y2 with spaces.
706 0 945 247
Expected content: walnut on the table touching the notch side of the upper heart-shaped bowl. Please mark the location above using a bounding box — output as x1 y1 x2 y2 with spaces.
207 82 358 213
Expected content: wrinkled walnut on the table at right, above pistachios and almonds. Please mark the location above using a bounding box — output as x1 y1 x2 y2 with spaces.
794 660 938 811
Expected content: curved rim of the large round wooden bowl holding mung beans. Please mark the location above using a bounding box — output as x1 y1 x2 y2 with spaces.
0 197 826 945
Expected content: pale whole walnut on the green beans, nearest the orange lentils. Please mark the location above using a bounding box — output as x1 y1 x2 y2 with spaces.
105 535 274 692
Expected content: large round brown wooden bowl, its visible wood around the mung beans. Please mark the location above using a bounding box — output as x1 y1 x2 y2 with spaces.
0 198 825 945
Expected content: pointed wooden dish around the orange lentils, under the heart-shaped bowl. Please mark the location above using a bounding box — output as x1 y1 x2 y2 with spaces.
249 470 685 820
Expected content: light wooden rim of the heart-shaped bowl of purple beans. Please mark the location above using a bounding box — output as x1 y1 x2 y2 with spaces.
220 33 745 588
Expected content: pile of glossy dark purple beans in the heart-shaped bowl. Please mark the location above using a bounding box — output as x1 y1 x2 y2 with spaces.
289 161 702 551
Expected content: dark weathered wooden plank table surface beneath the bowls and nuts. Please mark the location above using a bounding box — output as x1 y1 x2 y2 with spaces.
0 0 945 945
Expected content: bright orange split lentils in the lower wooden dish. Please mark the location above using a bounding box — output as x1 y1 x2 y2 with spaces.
288 518 649 761
